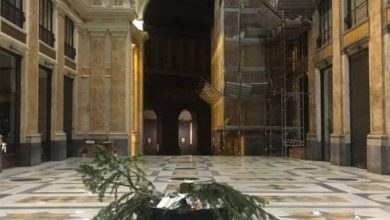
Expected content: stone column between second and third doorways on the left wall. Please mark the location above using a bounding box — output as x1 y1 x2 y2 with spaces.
50 7 66 160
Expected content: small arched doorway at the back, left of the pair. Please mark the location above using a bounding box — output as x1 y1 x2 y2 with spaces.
143 109 160 155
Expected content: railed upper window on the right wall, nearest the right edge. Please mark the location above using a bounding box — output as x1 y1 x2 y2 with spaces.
344 0 368 29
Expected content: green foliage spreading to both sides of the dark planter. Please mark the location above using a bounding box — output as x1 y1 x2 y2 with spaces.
77 146 276 220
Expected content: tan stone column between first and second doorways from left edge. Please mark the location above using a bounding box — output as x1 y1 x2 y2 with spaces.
19 0 42 166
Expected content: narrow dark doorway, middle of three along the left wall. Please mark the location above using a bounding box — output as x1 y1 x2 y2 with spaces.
38 66 52 161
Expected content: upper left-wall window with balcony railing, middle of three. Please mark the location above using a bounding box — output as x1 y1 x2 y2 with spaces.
39 0 55 47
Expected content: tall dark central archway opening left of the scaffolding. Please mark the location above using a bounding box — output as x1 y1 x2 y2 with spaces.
142 0 214 155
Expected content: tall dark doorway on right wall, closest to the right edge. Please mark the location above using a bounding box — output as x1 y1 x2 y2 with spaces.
349 50 370 169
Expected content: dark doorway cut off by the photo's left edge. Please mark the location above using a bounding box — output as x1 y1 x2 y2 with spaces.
0 48 21 168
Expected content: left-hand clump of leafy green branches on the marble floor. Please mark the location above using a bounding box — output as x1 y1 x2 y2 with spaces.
77 146 162 220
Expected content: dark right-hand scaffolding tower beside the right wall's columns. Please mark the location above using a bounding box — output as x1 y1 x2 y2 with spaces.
266 17 307 158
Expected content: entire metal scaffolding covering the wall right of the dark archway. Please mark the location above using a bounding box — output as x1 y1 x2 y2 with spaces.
214 0 307 157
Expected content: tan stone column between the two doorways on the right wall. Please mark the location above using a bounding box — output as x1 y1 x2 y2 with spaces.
330 1 351 166
